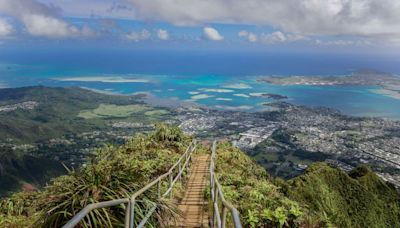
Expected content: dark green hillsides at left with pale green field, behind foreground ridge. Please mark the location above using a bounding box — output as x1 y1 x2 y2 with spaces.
0 86 170 197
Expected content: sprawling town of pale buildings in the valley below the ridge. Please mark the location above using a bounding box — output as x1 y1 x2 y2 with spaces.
0 102 400 187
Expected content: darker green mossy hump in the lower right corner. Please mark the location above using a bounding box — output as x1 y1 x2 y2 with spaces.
286 163 400 227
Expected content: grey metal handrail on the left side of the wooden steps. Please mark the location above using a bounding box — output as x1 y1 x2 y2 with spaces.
63 140 197 228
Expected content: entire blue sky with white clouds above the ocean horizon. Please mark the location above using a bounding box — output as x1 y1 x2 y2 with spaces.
0 0 400 55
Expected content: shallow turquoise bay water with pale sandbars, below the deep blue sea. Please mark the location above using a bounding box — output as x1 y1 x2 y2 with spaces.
0 64 400 119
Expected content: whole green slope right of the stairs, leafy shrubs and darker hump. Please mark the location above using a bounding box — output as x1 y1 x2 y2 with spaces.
217 143 400 228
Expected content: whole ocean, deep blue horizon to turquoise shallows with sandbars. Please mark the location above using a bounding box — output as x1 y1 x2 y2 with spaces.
0 49 400 119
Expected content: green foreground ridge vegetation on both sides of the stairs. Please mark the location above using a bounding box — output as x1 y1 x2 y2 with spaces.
0 125 400 228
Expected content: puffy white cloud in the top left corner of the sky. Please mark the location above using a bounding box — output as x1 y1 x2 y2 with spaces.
0 0 94 38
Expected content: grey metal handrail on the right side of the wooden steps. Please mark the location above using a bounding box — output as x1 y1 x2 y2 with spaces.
210 141 242 228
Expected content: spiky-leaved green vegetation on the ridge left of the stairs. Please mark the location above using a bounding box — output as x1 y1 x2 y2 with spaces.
0 125 191 227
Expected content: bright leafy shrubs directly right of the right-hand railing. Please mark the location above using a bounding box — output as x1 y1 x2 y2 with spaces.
216 142 303 227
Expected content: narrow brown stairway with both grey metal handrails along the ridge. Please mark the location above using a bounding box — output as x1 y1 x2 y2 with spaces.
63 140 242 228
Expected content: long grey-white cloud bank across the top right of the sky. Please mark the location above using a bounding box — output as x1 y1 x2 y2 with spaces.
130 0 400 39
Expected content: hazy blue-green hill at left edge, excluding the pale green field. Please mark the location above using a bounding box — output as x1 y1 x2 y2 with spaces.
0 87 145 143
